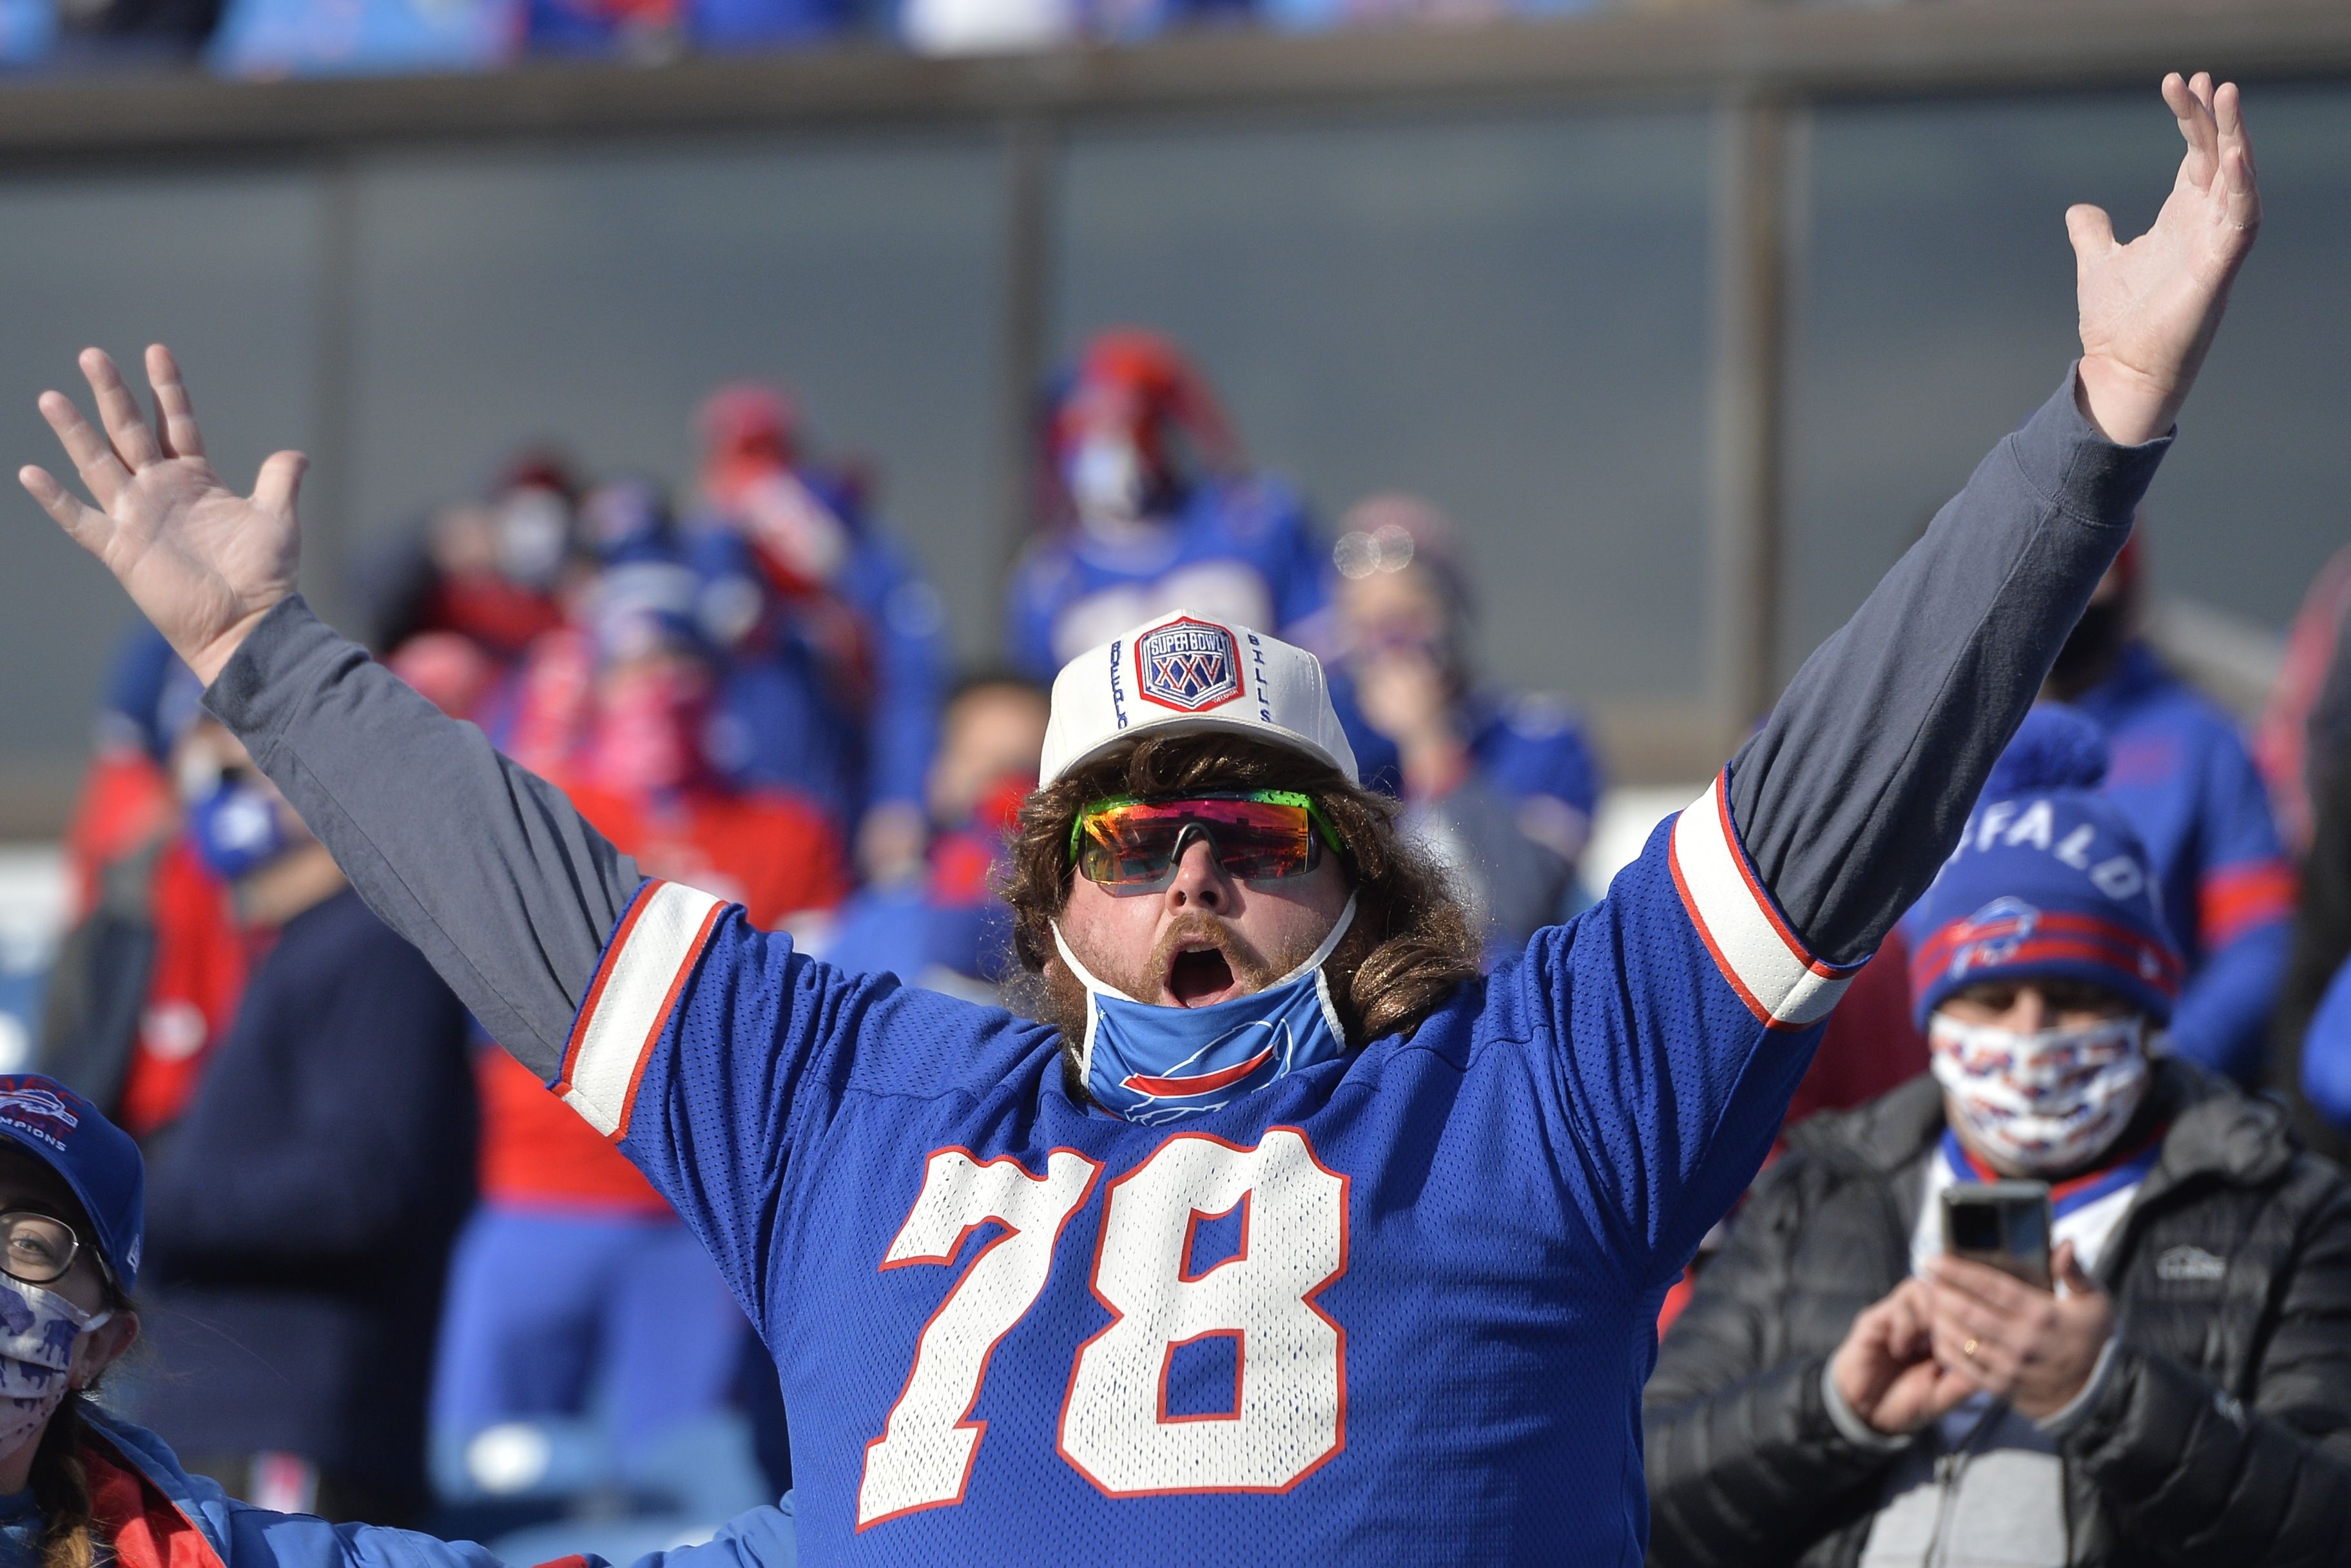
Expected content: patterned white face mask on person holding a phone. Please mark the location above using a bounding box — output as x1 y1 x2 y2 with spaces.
1928 1013 2147 1176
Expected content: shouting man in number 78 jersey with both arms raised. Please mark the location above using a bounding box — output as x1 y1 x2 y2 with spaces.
21 75 2259 1568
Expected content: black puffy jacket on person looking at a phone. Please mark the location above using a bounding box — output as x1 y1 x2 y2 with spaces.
1643 1060 2351 1568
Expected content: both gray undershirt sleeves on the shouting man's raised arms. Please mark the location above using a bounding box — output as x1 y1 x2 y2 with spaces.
204 371 2170 1074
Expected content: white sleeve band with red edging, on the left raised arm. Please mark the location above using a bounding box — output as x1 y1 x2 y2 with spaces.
555 882 726 1143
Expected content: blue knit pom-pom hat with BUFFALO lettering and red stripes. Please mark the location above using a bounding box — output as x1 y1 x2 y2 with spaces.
1911 703 2182 1027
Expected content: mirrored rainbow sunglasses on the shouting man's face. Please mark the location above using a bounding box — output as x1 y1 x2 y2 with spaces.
1070 790 1345 893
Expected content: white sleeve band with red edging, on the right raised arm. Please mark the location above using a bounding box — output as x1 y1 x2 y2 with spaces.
1672 773 1853 1030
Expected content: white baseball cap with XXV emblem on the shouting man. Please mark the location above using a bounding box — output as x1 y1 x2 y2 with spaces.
1041 609 1361 783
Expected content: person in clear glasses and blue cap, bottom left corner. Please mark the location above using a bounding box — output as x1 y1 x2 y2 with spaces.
0 1072 795 1568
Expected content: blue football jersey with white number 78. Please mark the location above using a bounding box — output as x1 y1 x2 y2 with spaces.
538 776 1850 1568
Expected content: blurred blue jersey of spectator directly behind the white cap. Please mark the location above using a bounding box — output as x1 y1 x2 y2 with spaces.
1006 479 1331 682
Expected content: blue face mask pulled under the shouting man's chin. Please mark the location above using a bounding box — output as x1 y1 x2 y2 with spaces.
1053 896 1354 1126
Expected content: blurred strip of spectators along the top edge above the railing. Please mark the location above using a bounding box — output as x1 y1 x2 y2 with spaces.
0 0 1601 80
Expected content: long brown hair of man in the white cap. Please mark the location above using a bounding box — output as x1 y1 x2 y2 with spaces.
1001 733 1479 1081
